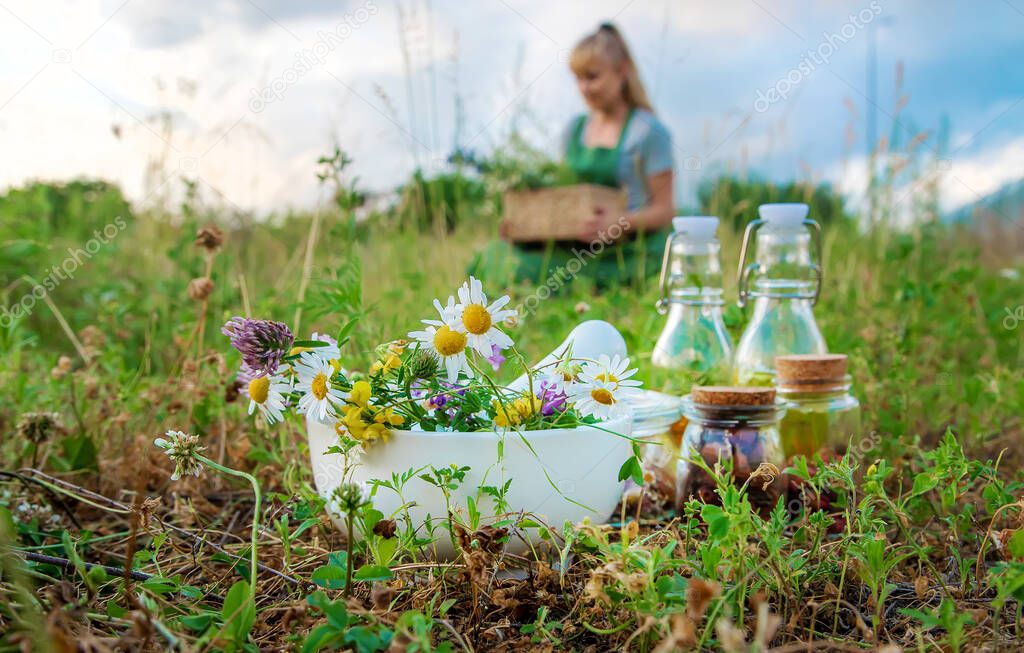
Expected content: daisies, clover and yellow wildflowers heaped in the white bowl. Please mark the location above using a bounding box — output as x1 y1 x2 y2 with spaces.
222 277 640 447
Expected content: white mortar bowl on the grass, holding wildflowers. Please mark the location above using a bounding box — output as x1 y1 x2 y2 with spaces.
306 418 633 558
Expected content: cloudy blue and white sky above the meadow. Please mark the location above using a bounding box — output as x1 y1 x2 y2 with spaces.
0 0 1024 212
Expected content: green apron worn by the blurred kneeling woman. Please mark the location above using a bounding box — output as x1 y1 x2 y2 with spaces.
469 111 668 292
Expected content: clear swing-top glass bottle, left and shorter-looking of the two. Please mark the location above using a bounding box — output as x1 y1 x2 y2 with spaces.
650 216 732 386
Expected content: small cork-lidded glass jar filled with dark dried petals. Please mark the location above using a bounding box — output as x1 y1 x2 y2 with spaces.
676 386 786 516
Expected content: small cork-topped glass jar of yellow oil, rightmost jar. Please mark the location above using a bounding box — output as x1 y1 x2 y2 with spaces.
775 354 861 459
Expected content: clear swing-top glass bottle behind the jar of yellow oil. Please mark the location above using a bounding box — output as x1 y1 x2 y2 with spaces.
733 204 827 386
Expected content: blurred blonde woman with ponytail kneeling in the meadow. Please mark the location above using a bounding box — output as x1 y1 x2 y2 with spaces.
471 23 675 286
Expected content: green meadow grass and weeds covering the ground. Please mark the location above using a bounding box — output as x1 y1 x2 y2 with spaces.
0 176 1024 651
